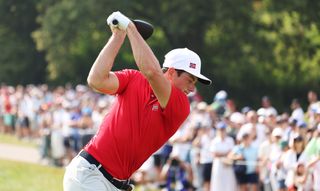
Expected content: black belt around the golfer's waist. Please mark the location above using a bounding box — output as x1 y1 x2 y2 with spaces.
79 150 132 191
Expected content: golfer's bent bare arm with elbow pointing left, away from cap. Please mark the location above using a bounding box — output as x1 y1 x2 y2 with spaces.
87 31 126 94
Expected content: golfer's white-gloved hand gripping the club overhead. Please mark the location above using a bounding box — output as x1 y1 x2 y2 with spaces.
107 11 131 31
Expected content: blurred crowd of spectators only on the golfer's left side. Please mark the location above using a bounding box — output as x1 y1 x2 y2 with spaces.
0 85 114 166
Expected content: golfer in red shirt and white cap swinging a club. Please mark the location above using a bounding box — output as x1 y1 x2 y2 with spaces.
63 12 211 191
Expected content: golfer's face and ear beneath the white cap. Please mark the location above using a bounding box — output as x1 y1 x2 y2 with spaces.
174 72 198 95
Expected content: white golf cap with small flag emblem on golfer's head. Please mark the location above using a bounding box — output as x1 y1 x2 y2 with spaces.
163 48 211 85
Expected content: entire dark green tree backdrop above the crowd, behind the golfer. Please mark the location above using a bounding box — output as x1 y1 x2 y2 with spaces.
0 0 320 107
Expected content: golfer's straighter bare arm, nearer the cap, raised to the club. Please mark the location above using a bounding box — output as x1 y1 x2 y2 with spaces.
127 22 171 108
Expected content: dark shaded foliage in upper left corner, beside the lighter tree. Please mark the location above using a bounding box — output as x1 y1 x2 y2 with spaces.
0 0 46 84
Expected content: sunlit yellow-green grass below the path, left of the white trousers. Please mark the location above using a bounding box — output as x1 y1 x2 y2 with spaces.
0 160 64 191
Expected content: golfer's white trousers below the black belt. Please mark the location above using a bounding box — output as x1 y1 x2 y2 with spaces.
63 156 119 191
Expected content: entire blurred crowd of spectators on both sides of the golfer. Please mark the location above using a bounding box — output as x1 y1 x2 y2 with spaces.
0 85 320 191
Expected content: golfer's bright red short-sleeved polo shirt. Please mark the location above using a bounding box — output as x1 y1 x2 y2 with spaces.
85 70 190 179
